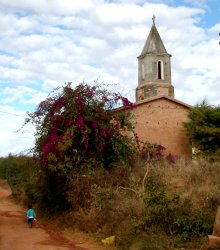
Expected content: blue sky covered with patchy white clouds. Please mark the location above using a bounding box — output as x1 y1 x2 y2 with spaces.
0 0 220 156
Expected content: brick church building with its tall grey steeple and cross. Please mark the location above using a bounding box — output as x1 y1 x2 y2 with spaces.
132 17 191 156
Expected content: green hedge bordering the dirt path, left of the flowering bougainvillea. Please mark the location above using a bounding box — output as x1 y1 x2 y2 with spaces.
2 155 67 214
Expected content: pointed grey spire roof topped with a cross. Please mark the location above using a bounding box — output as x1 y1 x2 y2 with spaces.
140 16 167 56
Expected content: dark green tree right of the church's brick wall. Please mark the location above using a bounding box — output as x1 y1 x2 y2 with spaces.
184 101 220 159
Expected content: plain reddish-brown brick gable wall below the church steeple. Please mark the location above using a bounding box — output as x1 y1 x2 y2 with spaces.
133 98 191 156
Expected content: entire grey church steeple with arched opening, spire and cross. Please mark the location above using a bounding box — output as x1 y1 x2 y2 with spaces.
136 16 174 101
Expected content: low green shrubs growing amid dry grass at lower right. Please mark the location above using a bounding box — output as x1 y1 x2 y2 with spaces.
139 179 213 241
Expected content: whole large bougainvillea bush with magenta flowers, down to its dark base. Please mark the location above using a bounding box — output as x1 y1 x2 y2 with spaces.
22 83 167 211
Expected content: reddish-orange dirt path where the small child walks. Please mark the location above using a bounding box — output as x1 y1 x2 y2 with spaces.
0 180 107 250
